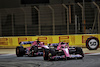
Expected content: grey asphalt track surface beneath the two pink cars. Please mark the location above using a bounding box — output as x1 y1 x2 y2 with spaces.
0 51 100 67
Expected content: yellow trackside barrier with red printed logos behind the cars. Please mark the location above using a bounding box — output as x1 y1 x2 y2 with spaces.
0 34 100 48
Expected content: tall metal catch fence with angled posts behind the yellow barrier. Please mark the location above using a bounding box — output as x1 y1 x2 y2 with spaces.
0 2 100 36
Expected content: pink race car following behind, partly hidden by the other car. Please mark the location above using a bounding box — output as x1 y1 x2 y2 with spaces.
16 40 49 57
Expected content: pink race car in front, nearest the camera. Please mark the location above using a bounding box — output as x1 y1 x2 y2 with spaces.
43 42 84 60
